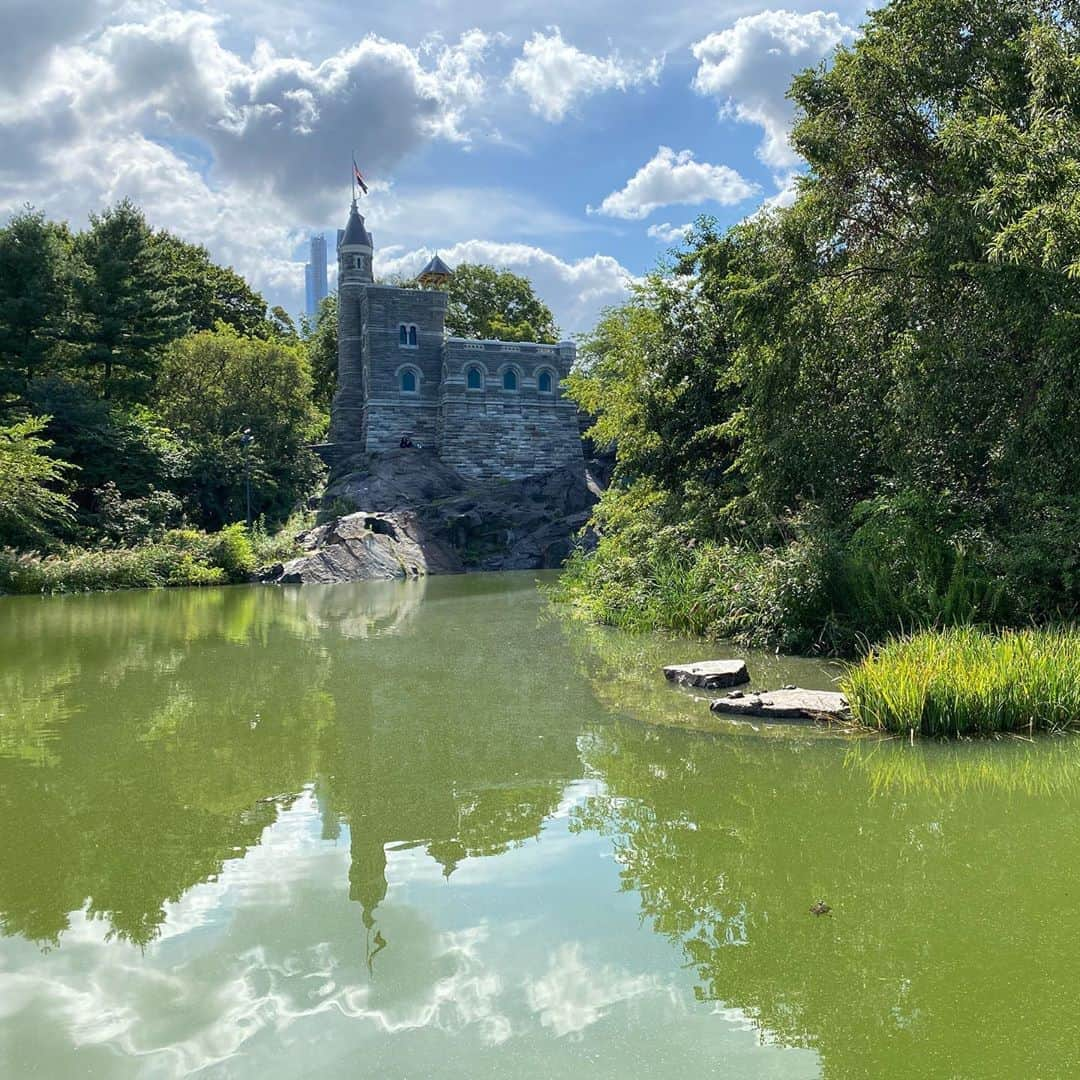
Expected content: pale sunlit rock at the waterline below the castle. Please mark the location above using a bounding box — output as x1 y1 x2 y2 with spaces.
261 511 464 585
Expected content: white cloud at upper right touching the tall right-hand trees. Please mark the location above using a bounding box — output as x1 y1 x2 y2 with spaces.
693 10 854 168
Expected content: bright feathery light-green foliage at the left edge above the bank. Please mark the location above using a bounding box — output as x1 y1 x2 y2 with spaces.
0 417 71 544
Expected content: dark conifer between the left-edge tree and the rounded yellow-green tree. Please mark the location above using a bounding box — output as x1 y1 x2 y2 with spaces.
76 199 187 401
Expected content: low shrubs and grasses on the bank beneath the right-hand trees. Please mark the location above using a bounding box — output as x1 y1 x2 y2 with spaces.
552 514 1015 656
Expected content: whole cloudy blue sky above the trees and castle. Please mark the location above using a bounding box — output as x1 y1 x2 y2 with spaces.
0 0 865 334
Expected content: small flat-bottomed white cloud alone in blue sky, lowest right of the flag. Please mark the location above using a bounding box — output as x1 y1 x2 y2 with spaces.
589 146 759 220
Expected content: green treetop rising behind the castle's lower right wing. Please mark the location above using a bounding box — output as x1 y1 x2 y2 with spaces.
446 262 558 343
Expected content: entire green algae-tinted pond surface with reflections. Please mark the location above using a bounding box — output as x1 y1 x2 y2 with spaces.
0 575 1080 1080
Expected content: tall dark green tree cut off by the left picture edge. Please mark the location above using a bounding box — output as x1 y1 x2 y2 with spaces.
0 206 73 394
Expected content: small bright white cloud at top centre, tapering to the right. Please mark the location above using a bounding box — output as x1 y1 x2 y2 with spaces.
507 26 664 123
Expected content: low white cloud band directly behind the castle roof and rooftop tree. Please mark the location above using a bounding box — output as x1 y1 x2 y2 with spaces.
375 240 634 334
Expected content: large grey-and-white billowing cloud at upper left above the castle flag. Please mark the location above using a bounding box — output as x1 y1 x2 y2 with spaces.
0 10 491 220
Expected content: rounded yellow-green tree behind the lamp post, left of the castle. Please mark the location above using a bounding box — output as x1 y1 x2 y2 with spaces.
156 325 321 528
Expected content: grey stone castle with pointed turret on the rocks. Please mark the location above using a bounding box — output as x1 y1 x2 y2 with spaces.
330 201 584 480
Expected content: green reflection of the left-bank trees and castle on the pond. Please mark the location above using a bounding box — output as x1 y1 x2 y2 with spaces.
0 579 577 946
